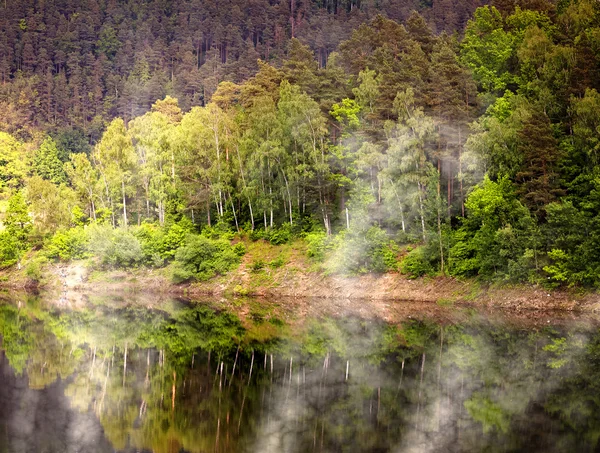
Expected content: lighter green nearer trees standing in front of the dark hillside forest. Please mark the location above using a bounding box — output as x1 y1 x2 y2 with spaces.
0 0 600 286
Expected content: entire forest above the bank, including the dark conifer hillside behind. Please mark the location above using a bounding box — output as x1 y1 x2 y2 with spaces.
0 0 600 286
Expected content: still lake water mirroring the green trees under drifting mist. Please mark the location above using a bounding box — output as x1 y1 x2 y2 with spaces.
0 299 600 453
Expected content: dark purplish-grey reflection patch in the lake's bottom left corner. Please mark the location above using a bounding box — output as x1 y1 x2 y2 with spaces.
0 353 114 453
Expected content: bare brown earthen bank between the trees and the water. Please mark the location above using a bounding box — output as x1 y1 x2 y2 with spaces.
0 240 600 312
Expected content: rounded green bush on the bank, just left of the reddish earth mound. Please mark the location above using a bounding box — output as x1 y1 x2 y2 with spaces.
173 235 240 283
